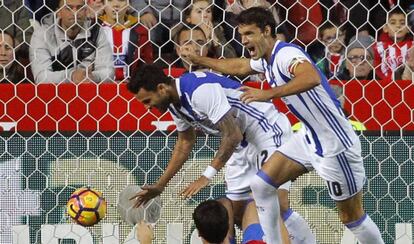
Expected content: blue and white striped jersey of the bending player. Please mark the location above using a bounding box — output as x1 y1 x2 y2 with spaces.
169 72 290 149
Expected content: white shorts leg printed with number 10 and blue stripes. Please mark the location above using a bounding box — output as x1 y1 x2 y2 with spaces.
312 141 366 201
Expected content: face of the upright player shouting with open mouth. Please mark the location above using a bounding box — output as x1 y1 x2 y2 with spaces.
238 24 267 60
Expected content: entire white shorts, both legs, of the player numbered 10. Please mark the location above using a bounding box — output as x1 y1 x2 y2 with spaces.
277 129 365 201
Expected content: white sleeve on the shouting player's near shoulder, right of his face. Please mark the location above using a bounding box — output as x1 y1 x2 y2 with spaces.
275 46 312 79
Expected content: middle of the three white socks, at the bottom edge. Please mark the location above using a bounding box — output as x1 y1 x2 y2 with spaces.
282 208 316 244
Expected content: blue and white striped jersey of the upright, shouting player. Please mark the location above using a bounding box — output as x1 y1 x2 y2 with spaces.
250 41 359 157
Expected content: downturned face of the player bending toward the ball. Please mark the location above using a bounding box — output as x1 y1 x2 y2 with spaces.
135 87 172 113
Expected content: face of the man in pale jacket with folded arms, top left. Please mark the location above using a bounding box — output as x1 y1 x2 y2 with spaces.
58 0 87 29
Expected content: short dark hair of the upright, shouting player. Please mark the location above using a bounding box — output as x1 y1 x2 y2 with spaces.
236 7 276 37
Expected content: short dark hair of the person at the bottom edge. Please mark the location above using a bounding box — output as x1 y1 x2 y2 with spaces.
193 200 229 243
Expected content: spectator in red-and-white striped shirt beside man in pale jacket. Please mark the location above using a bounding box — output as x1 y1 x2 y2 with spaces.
99 0 153 81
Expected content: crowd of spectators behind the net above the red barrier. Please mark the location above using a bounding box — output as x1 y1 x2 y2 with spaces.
0 0 414 83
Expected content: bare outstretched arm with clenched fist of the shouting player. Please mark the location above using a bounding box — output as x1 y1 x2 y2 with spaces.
181 46 257 76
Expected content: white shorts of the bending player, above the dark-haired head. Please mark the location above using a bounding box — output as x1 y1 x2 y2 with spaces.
225 144 291 201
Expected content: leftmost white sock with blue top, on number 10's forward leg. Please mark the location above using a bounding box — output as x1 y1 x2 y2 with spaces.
250 170 282 244
